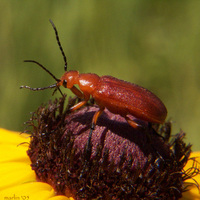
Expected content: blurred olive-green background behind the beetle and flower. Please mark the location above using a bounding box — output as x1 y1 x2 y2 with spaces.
0 0 200 150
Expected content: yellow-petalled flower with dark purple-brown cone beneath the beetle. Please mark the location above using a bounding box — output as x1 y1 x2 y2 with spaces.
0 98 199 199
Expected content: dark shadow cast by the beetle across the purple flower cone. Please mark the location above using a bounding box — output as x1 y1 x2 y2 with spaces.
71 109 169 158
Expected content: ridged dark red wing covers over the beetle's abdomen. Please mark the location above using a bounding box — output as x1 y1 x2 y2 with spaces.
93 76 167 123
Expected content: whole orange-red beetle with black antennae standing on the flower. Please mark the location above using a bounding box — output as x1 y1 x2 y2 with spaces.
20 20 167 145
